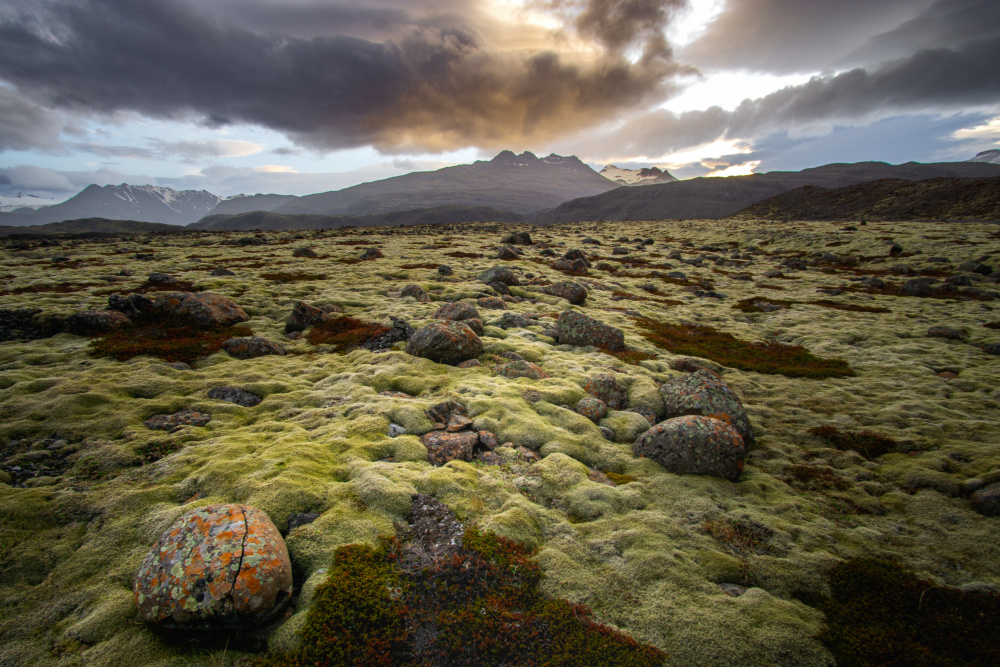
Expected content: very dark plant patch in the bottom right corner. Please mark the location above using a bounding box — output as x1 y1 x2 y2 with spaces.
818 559 1000 667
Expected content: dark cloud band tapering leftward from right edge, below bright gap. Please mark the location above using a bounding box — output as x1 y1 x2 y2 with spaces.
572 37 1000 156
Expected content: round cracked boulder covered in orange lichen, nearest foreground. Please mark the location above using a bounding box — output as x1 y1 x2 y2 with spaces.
132 505 292 629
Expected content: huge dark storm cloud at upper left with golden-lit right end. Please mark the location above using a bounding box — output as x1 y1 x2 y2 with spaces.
0 0 678 150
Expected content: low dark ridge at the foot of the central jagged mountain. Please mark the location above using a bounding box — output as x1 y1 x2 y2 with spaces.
186 206 522 231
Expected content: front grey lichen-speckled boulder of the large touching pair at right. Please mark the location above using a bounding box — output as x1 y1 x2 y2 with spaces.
632 415 746 481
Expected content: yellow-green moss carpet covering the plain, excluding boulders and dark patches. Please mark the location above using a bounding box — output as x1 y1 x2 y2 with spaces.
0 221 1000 666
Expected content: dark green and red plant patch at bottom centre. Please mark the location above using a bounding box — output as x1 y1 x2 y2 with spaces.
263 528 666 667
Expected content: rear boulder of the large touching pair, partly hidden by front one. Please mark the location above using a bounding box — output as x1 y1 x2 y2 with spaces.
660 370 756 449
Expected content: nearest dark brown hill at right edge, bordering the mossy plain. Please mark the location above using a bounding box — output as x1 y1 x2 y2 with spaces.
733 176 1000 221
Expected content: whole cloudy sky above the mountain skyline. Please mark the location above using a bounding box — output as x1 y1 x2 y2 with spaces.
0 0 1000 201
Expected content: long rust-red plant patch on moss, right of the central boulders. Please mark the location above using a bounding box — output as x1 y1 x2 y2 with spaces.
636 318 855 380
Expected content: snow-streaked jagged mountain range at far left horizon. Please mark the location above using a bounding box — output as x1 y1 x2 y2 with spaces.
0 183 222 226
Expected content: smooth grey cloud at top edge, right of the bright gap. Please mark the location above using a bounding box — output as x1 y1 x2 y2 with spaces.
681 0 940 73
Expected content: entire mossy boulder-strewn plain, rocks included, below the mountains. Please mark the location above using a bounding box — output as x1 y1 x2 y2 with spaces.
0 218 1000 666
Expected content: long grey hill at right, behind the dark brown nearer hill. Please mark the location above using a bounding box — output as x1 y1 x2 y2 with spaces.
528 162 1000 225
